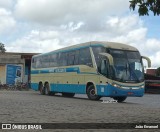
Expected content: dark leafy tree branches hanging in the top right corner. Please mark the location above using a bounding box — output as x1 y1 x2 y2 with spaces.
129 0 160 16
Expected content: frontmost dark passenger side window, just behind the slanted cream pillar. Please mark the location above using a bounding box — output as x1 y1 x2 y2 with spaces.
79 48 92 66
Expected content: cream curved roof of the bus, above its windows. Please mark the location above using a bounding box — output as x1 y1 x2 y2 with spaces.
34 41 138 57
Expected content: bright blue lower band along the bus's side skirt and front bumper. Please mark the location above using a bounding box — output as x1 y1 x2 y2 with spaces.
31 83 144 97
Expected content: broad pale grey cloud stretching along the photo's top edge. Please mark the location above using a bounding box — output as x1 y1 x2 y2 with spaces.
14 0 129 25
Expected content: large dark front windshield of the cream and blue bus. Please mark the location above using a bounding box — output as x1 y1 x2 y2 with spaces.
110 49 144 83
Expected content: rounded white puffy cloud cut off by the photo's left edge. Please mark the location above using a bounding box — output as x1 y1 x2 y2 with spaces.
0 8 16 34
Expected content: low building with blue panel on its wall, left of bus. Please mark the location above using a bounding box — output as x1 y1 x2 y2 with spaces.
0 52 37 84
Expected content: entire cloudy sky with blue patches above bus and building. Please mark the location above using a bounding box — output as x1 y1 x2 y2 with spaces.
0 0 160 67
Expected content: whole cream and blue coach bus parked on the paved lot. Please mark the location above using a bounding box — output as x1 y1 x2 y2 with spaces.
31 41 151 102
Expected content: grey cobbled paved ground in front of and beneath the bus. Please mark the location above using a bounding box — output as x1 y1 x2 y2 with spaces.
0 90 160 131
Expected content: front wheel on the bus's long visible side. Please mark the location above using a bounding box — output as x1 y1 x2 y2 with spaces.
87 85 101 100
